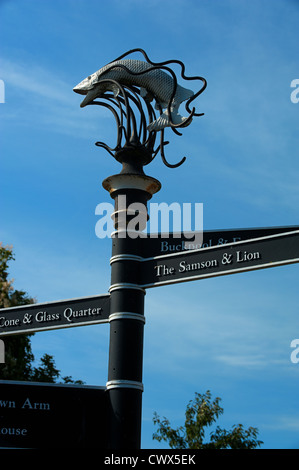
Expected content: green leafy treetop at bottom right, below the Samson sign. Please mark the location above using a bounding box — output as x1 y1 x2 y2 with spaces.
153 390 263 449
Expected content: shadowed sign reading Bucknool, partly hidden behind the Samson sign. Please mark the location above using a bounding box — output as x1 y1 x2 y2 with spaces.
141 226 299 258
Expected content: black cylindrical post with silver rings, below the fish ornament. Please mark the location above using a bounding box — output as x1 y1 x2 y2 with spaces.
103 161 161 449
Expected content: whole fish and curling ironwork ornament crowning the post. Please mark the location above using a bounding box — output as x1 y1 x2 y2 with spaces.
74 48 207 168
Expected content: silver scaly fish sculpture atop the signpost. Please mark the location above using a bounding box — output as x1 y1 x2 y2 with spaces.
73 59 194 131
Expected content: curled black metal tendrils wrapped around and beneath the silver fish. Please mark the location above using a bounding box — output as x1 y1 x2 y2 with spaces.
85 48 207 168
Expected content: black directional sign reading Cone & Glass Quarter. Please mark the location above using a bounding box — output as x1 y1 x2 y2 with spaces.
0 294 110 336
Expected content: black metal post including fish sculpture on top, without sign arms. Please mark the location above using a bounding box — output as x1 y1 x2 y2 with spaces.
74 48 207 449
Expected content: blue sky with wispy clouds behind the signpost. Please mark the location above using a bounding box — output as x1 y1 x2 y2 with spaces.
0 0 299 448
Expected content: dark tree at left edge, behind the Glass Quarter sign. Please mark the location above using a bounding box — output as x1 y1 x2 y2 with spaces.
0 242 83 384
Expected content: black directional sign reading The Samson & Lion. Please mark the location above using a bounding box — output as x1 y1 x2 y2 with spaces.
141 230 299 287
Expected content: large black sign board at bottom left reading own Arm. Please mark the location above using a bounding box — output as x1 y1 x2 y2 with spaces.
0 380 107 449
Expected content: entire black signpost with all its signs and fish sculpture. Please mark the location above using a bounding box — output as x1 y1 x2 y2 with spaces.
0 49 299 449
